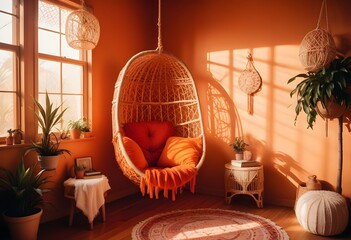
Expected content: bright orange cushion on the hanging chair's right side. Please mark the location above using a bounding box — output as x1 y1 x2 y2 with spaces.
157 137 202 167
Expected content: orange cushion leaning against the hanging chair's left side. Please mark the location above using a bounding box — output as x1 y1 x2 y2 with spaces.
123 137 149 172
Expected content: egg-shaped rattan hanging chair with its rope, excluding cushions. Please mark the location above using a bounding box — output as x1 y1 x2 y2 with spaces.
112 0 206 184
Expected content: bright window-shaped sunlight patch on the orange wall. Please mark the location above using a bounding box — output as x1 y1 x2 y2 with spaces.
207 45 322 188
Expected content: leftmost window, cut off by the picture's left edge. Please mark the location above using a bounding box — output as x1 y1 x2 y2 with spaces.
0 0 20 138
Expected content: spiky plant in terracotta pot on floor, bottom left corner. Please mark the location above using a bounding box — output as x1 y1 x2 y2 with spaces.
0 158 49 240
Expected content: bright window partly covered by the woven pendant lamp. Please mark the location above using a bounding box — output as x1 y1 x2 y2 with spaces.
37 0 88 129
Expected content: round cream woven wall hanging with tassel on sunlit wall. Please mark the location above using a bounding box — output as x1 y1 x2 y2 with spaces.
239 53 262 114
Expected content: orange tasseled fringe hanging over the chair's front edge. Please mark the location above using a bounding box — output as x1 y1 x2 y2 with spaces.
139 174 196 201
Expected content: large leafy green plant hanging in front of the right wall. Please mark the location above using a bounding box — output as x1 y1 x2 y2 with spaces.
288 57 351 129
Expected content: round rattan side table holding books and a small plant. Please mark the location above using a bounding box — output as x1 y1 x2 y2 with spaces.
224 163 264 208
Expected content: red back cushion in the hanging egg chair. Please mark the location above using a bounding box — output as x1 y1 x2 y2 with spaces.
124 121 174 166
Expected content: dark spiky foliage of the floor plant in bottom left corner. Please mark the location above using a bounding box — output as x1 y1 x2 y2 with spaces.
0 158 49 217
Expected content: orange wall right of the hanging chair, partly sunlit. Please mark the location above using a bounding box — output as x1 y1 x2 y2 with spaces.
158 0 351 205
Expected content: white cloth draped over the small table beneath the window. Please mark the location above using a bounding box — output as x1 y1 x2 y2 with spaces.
64 176 111 223
